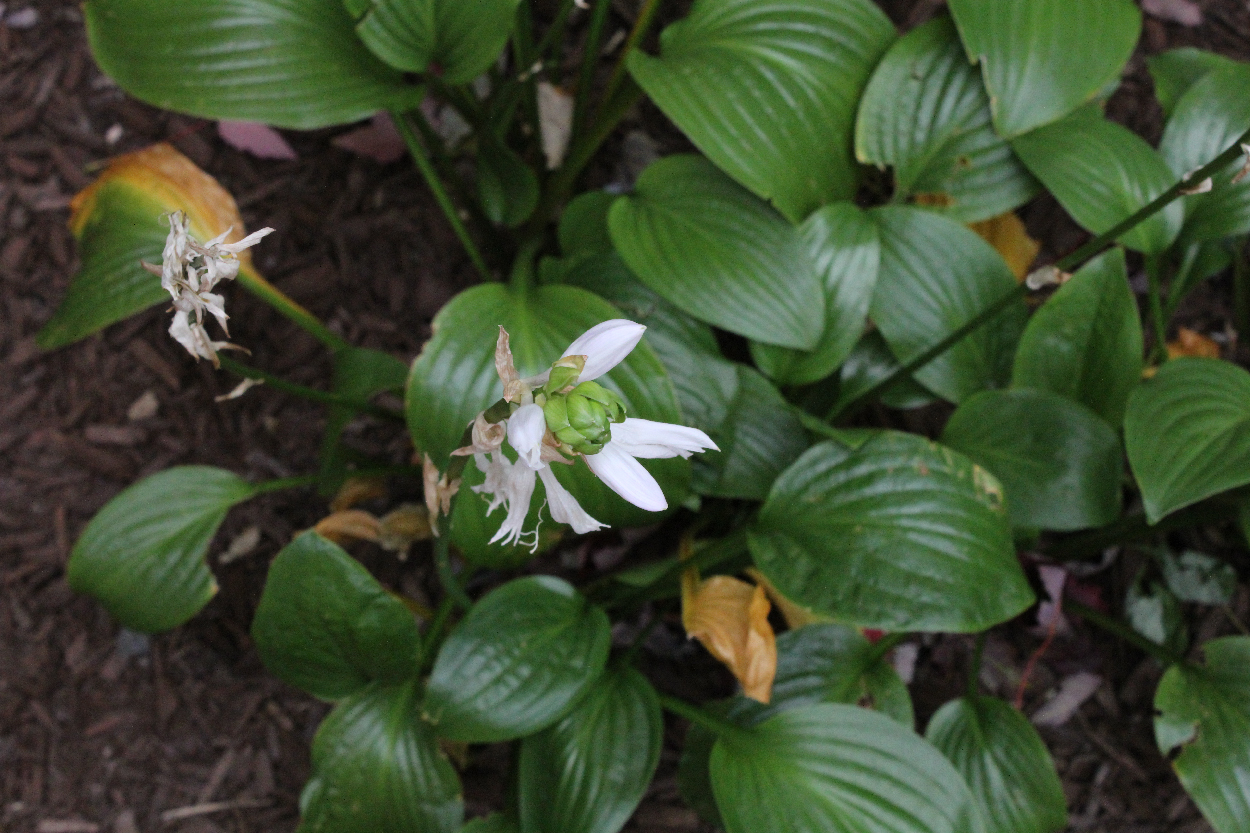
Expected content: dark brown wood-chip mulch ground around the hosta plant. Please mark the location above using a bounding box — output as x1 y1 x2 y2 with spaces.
0 0 1250 833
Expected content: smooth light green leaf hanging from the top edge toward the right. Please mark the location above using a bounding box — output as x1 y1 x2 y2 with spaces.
950 0 1141 137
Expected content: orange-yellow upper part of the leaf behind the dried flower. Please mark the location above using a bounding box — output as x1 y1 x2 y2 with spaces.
70 143 254 274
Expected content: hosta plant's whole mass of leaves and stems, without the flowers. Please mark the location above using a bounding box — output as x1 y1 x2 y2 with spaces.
34 0 1250 833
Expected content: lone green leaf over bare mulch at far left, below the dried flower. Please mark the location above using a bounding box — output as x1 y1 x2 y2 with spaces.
66 465 255 633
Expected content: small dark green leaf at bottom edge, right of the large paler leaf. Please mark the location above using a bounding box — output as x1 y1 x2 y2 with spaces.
925 697 1068 833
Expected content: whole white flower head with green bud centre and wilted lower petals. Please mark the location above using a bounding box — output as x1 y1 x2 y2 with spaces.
456 319 716 549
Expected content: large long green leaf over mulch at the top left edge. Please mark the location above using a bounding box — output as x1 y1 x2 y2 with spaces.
84 0 423 129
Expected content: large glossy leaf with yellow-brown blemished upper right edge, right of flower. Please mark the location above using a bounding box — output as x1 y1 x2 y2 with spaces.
749 432 1033 632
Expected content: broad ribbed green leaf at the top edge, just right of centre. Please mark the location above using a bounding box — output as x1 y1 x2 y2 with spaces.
628 0 895 223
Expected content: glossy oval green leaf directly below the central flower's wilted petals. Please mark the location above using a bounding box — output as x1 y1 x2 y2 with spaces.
424 575 611 743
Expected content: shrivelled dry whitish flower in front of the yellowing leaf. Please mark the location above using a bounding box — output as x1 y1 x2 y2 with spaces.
144 211 273 366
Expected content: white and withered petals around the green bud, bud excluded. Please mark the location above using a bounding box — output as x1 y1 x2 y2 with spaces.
470 319 716 549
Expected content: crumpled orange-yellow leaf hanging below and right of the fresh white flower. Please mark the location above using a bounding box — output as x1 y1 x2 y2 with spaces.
681 568 778 703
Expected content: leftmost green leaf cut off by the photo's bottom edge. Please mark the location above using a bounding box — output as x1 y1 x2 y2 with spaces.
298 683 464 833
